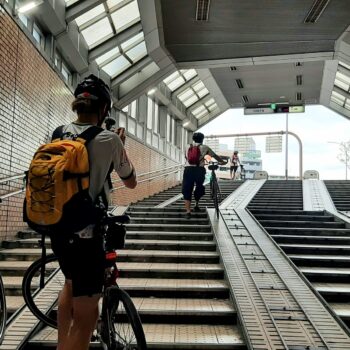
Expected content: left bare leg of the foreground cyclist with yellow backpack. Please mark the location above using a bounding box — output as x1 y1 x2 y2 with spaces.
57 280 73 350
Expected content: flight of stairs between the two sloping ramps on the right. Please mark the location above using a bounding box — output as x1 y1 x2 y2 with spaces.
249 182 350 326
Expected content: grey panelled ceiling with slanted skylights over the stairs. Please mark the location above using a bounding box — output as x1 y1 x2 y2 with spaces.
6 0 350 130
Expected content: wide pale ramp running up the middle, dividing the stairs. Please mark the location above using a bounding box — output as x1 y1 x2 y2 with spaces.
215 181 350 350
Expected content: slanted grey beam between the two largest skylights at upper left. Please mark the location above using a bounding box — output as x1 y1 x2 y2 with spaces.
89 22 142 62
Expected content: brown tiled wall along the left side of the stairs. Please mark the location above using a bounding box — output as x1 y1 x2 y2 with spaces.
0 6 180 241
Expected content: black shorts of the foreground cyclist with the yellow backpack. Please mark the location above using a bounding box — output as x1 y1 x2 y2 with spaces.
51 234 105 297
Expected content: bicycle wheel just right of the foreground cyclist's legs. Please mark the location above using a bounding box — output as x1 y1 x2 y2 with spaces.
105 286 147 350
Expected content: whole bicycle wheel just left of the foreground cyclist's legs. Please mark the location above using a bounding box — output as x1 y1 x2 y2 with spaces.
22 254 61 328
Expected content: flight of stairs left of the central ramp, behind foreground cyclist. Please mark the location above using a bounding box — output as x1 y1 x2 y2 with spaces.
0 183 246 349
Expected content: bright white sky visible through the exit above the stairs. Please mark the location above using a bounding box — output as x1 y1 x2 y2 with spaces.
199 105 350 180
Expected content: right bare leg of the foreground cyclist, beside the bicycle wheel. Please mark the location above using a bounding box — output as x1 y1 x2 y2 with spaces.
62 296 100 350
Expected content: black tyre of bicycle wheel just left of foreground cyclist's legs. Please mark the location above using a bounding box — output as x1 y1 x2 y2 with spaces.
22 254 63 328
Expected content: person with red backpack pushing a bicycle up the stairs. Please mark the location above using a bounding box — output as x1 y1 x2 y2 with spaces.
182 132 226 219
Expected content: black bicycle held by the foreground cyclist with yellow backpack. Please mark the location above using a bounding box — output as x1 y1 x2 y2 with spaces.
22 215 147 350
